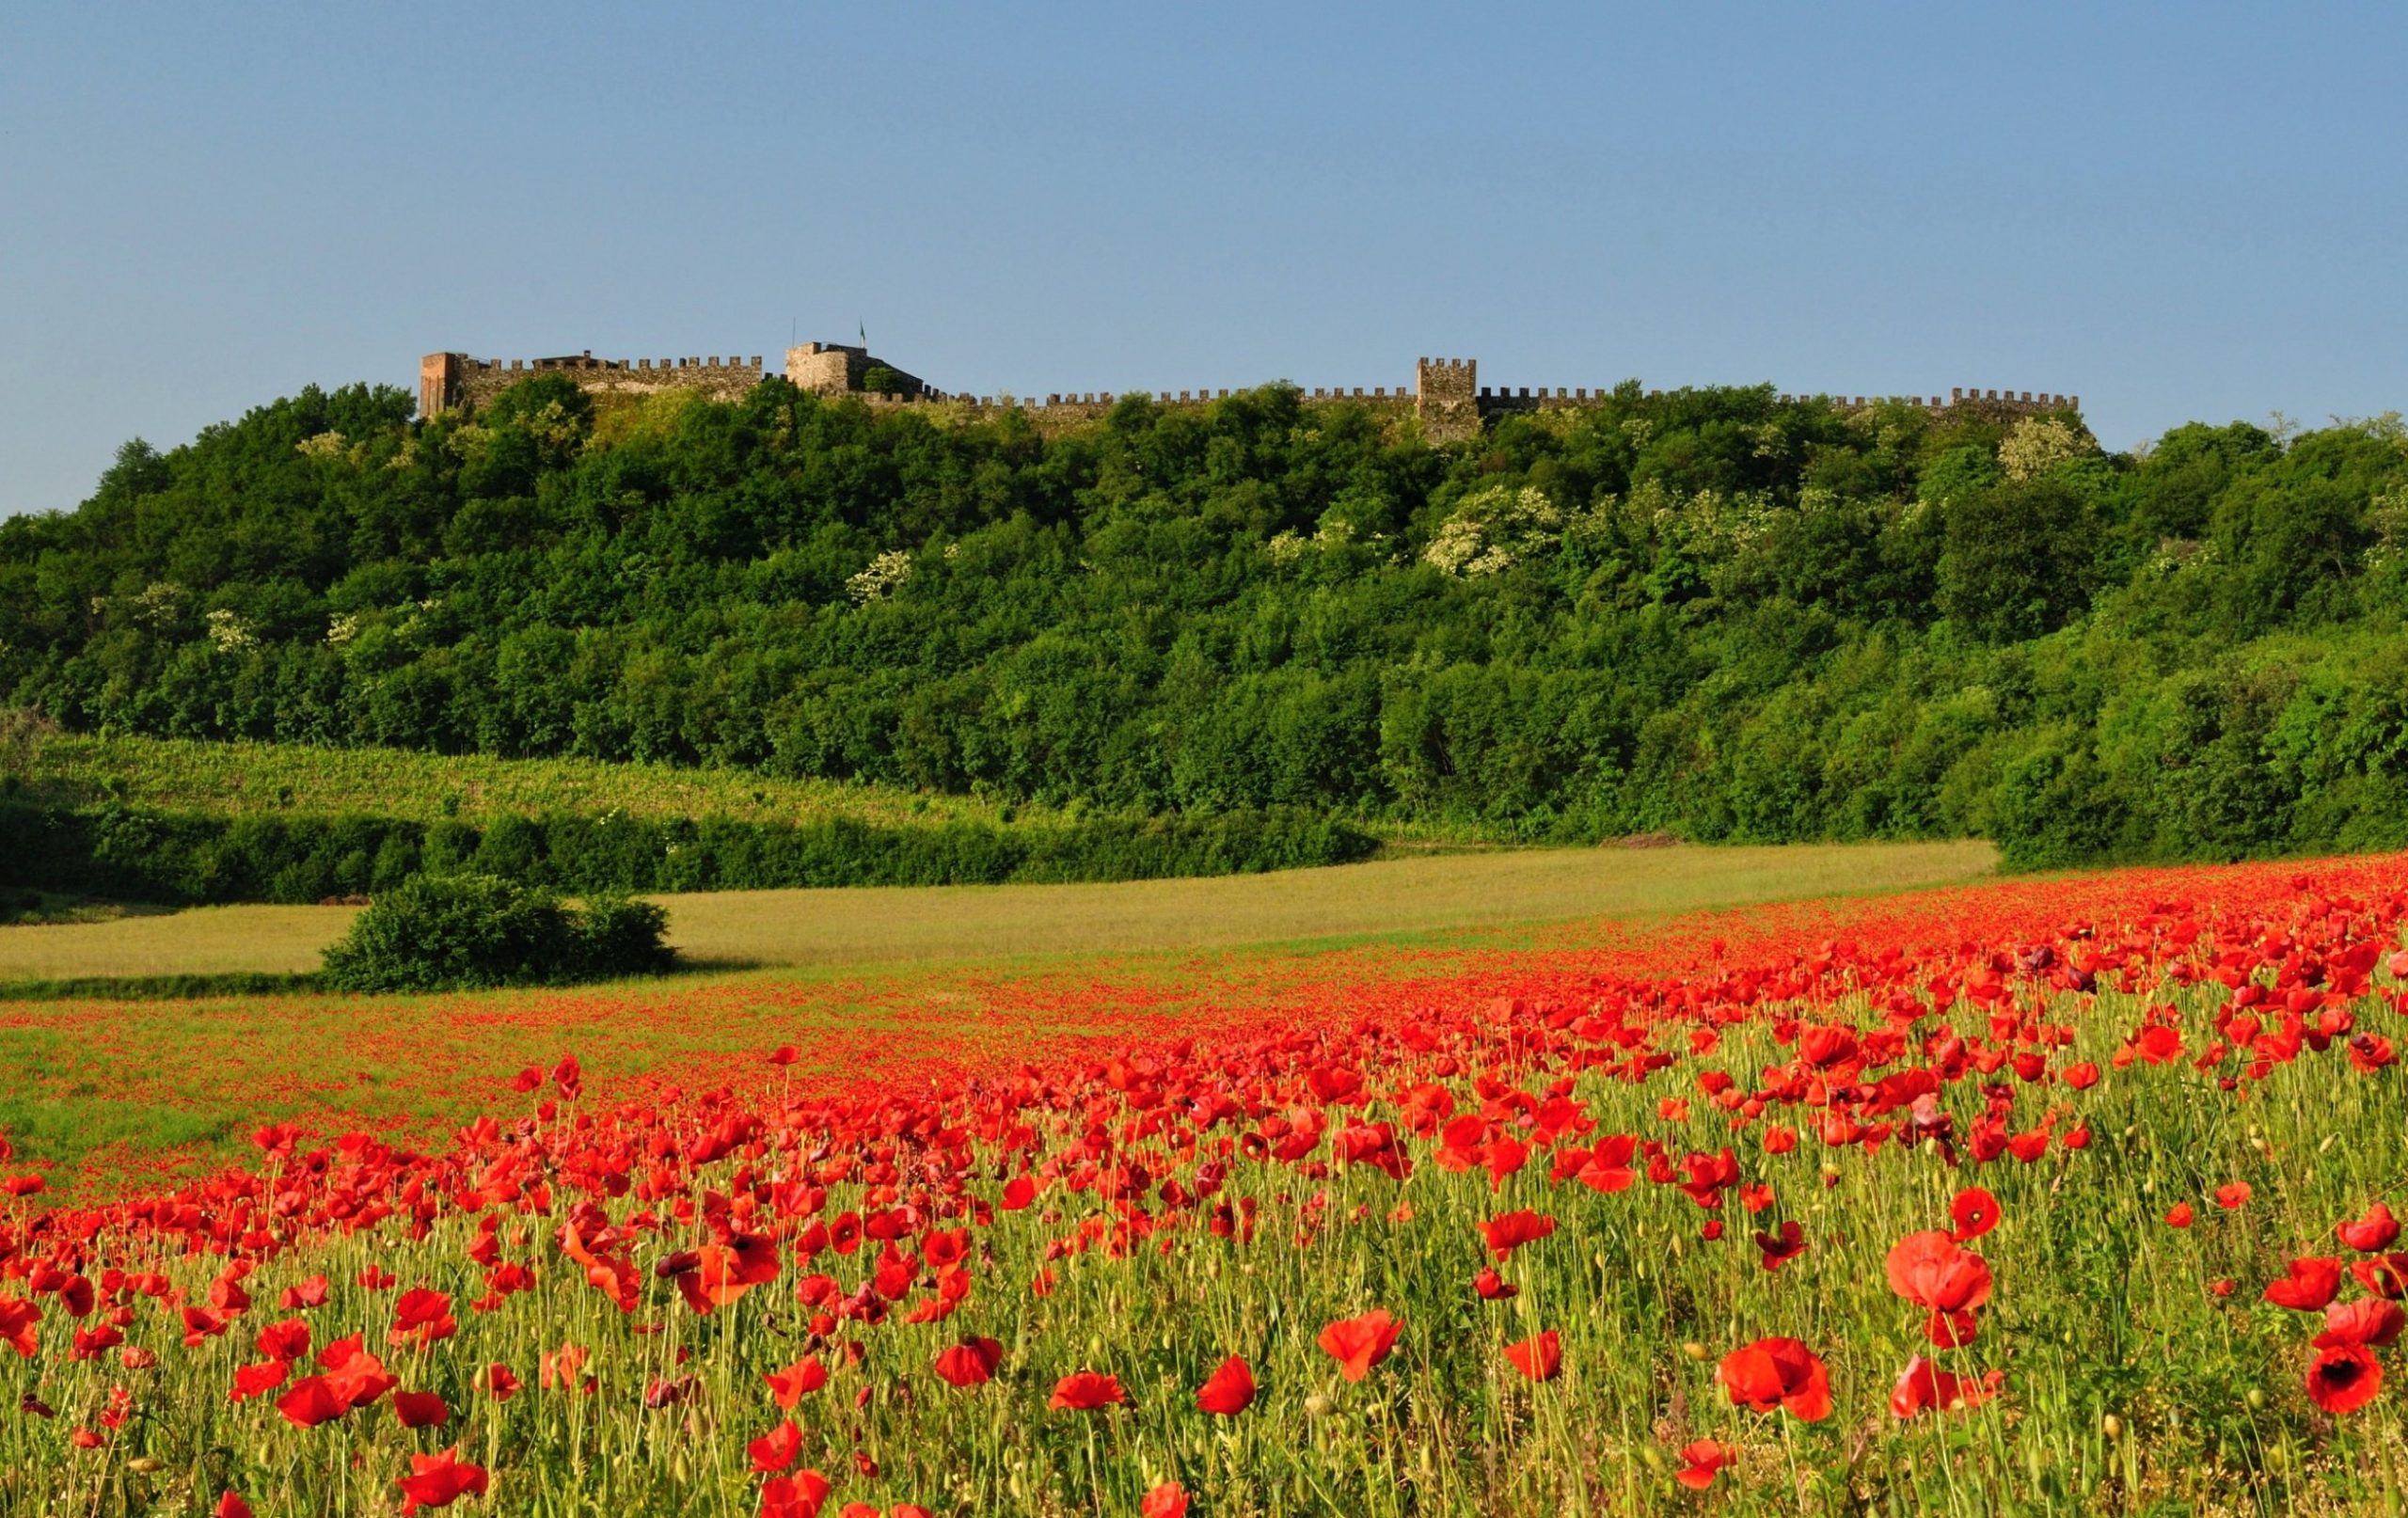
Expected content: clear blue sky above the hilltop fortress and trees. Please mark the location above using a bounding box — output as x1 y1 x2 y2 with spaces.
0 0 2408 514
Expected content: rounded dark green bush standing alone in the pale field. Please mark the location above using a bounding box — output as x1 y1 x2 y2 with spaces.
325 875 676 990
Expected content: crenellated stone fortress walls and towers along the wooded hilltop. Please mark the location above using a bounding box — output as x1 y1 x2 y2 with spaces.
419 342 2083 443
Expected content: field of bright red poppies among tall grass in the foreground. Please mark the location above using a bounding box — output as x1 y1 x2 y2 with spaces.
0 858 2408 1518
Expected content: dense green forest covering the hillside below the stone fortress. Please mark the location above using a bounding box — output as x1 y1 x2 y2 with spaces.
0 378 2408 865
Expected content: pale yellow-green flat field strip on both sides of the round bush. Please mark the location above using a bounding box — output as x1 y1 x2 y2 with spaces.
0 841 1996 983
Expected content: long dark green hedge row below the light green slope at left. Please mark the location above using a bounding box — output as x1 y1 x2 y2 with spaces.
0 805 1377 904
